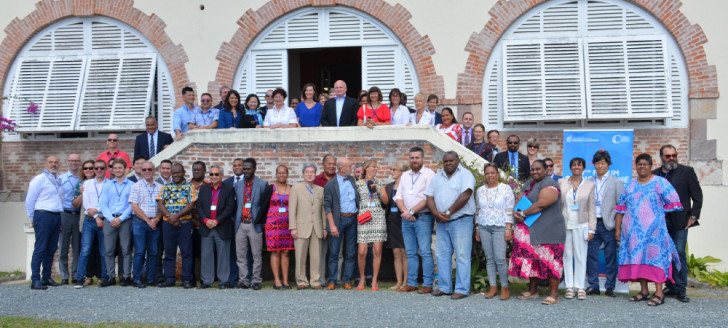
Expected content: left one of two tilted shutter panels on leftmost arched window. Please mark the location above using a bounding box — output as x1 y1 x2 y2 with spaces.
8 57 86 132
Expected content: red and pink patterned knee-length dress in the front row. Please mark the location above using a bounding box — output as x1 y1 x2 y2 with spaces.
265 185 294 252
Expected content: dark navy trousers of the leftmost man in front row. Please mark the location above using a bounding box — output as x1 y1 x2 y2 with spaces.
30 211 61 281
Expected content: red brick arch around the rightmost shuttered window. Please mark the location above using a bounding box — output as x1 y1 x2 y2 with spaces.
457 0 719 104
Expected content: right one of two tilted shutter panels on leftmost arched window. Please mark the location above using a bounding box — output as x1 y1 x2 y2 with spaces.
77 54 157 130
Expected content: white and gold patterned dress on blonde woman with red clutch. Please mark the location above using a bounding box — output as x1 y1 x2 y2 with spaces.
356 179 387 244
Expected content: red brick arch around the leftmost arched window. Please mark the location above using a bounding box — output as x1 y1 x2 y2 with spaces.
0 0 190 104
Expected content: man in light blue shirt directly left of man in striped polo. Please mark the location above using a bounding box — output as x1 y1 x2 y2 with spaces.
99 158 134 287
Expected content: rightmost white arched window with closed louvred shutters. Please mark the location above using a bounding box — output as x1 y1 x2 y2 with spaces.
483 0 688 128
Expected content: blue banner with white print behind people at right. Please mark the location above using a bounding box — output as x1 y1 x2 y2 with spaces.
563 130 634 184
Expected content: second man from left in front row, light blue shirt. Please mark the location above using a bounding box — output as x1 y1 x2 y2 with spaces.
58 154 81 285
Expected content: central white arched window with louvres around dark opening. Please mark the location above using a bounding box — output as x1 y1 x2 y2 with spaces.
234 7 419 99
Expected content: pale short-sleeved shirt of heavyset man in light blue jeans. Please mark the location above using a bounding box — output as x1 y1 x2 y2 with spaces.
425 165 475 221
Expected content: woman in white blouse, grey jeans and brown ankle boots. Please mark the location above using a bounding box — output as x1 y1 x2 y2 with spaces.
475 163 515 300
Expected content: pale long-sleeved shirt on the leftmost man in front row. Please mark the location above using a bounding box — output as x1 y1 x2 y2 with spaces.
25 170 63 221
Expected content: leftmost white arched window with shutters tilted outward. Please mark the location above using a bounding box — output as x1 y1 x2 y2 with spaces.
4 17 174 133
